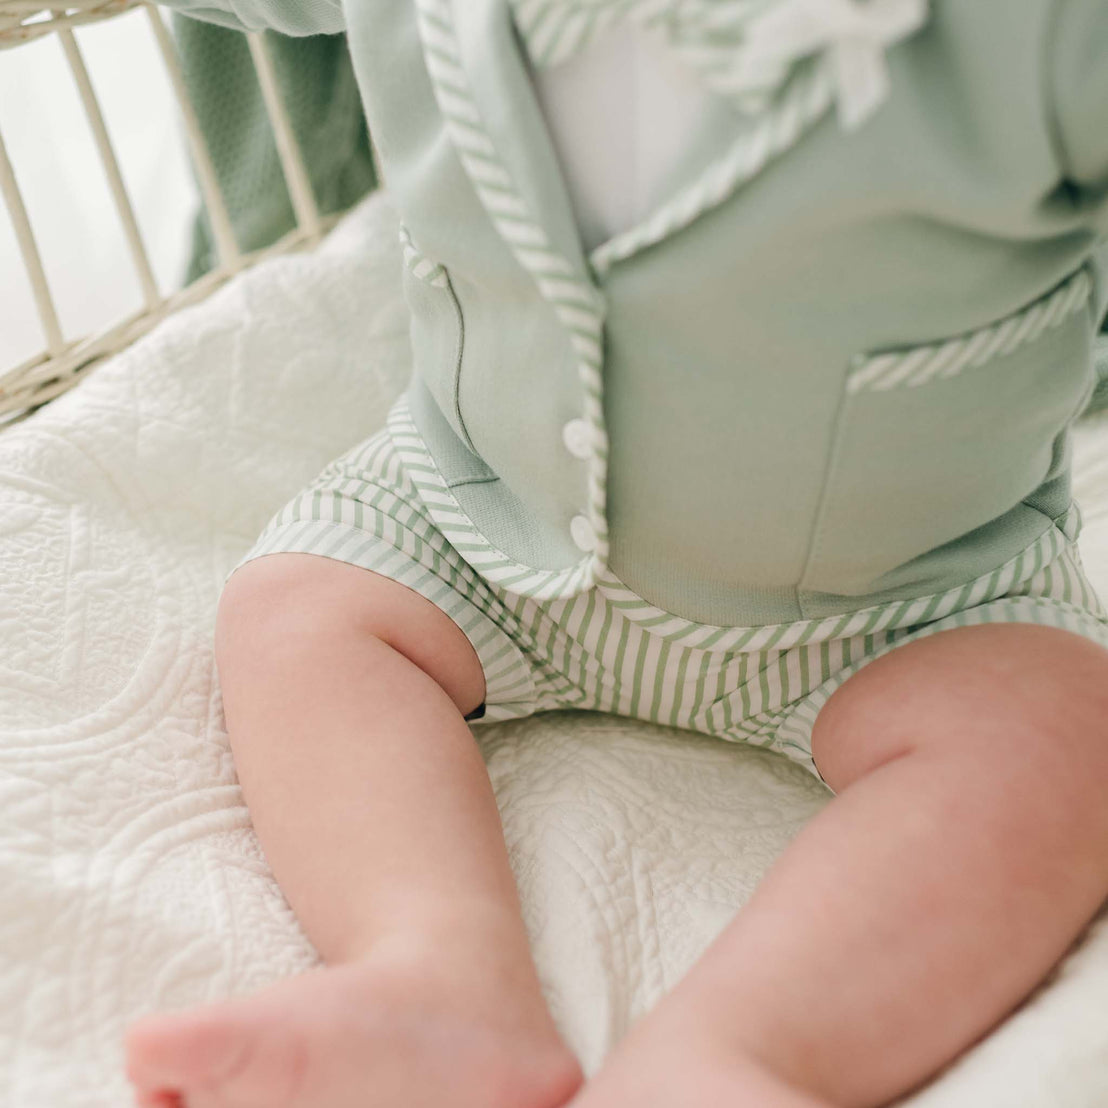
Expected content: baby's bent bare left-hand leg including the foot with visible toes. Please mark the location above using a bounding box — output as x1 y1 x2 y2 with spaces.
127 554 581 1108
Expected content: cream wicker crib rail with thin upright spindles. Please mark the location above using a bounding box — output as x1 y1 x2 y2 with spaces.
0 0 338 427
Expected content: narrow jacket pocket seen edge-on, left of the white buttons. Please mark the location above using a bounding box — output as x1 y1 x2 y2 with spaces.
400 224 476 453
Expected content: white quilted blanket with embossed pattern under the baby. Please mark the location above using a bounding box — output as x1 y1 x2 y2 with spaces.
0 192 1108 1108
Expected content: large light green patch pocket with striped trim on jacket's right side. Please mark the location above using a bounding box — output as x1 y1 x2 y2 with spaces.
800 269 1095 596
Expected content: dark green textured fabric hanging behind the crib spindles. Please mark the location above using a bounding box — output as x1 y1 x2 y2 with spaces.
174 17 377 280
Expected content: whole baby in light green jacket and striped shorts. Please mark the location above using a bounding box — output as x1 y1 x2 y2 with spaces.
127 0 1108 1108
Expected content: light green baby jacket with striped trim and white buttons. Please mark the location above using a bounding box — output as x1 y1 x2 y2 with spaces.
163 0 1108 626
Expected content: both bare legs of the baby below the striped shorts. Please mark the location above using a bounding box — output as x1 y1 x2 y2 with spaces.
127 554 1108 1108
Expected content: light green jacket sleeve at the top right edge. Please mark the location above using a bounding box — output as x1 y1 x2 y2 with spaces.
1047 0 1108 191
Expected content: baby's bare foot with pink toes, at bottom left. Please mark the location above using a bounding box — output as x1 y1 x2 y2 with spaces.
126 944 582 1108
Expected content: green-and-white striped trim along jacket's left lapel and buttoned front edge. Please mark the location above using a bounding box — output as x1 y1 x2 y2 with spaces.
416 0 608 596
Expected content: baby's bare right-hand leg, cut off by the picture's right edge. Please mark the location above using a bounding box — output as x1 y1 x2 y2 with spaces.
573 625 1108 1108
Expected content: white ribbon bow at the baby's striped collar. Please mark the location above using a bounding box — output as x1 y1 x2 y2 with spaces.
742 0 929 130
